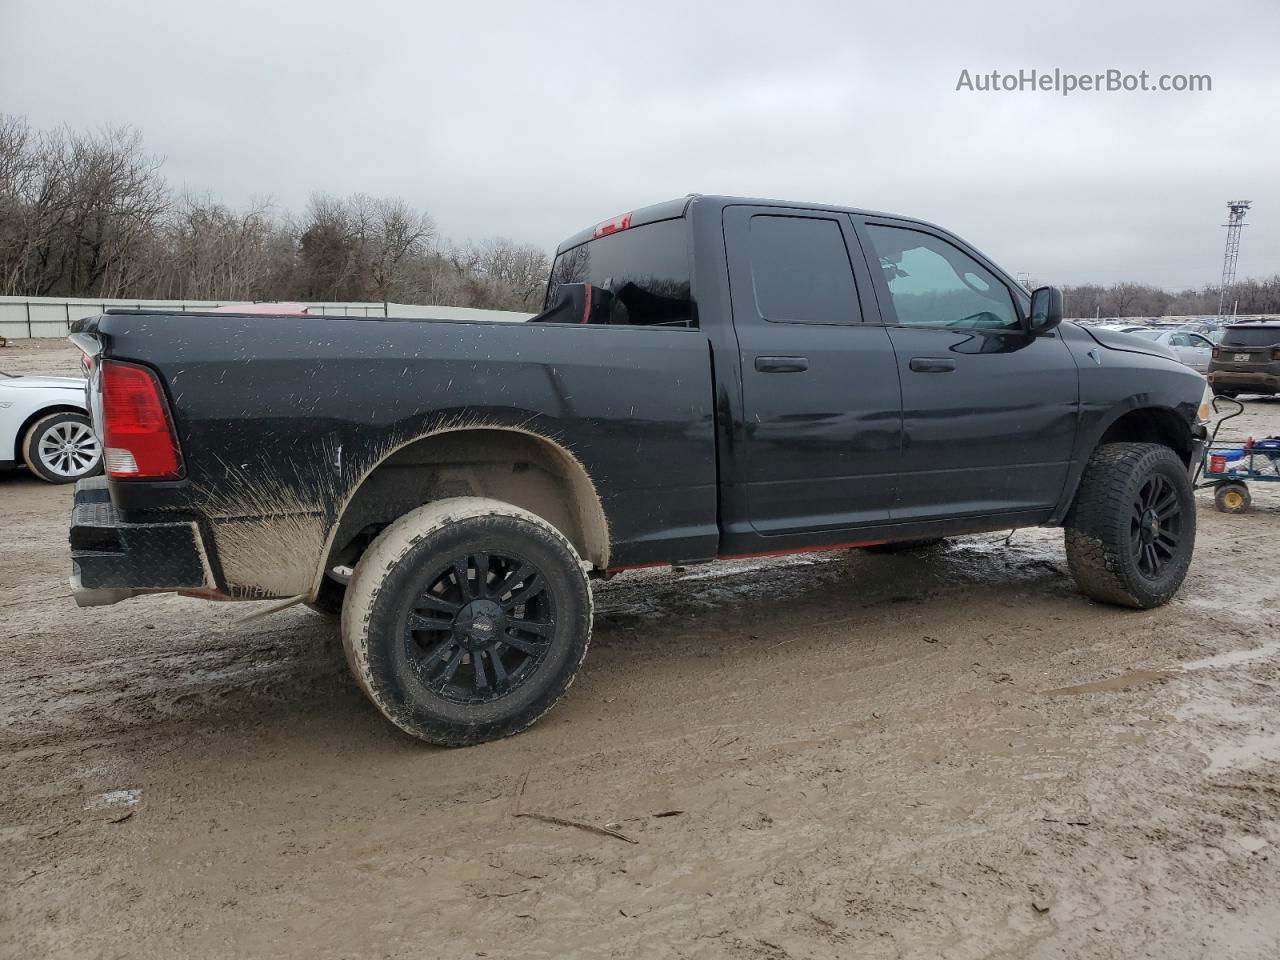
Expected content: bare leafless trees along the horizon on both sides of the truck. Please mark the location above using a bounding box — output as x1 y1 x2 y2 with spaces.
0 114 1280 317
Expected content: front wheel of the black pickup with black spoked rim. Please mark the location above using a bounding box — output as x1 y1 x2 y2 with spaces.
1064 443 1196 609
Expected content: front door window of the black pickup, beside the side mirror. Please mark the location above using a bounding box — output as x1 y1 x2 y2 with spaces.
867 225 1021 330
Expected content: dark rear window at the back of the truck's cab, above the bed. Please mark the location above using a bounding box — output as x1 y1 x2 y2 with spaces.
545 219 696 326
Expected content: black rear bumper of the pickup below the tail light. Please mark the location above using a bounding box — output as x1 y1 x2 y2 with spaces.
70 477 215 607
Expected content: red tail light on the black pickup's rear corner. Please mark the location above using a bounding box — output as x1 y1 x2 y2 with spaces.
102 360 182 480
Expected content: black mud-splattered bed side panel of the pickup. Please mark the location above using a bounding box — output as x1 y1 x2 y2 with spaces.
76 311 718 598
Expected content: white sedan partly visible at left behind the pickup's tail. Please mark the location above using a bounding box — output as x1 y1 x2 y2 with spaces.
0 371 102 484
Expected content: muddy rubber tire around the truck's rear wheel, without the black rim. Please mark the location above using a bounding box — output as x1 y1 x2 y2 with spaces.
342 497 593 746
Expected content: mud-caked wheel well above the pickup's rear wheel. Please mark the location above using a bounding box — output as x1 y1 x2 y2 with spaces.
325 428 609 583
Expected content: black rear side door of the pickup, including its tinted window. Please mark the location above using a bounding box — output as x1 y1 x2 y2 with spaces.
723 206 902 536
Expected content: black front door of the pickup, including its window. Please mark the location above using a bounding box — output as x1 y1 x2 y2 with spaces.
855 218 1079 521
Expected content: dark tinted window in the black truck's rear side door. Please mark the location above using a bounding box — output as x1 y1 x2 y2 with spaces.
749 214 863 324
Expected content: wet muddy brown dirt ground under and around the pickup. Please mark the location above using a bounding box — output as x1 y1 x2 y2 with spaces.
0 346 1280 960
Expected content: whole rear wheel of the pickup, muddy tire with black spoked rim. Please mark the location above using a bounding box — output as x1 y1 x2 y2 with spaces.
342 497 591 746
